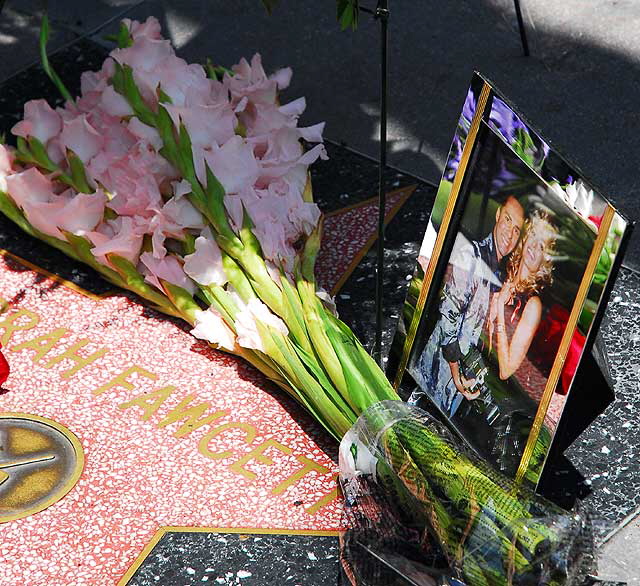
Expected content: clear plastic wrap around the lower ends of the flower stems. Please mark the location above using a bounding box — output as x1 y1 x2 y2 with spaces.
340 401 595 586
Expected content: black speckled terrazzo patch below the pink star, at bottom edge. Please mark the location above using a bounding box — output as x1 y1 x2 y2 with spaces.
128 533 340 586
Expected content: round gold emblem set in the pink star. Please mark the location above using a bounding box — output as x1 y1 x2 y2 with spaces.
0 413 84 523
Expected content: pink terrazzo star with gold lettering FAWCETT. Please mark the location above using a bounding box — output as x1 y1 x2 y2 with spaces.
0 190 410 586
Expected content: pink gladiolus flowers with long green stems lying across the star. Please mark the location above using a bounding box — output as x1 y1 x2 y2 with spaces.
0 18 596 584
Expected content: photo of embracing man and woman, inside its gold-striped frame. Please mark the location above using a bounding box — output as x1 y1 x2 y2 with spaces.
407 122 597 478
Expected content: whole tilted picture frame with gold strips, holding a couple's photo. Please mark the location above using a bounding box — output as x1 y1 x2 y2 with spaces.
388 74 630 486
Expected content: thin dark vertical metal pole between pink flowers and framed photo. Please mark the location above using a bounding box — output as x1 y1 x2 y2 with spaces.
373 0 389 366
